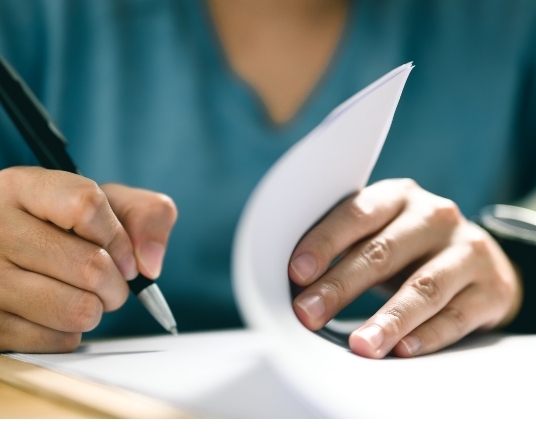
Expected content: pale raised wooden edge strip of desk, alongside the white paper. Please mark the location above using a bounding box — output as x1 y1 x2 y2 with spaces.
0 355 193 419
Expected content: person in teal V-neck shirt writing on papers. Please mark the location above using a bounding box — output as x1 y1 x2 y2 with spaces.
0 0 536 358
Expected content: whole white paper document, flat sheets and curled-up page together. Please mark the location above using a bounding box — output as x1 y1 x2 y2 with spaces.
10 64 536 418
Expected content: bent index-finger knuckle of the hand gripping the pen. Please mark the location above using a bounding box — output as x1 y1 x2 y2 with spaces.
69 179 108 224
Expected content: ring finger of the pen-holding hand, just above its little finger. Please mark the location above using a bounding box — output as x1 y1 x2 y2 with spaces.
0 265 103 332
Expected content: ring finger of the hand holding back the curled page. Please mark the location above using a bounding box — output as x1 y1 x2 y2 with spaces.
349 245 479 358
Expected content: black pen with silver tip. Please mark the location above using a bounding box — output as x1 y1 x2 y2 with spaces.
0 55 178 335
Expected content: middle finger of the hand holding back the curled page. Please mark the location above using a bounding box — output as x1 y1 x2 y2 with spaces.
293 208 450 330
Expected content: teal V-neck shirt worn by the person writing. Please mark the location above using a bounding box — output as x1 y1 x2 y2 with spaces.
0 0 536 336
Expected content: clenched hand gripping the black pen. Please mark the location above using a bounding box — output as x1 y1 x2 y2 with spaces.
0 167 177 353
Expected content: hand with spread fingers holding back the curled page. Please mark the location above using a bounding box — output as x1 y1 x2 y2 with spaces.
289 179 521 358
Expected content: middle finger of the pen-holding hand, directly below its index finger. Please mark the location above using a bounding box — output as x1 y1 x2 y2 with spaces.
0 209 128 311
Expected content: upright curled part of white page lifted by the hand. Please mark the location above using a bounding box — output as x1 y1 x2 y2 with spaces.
233 63 413 338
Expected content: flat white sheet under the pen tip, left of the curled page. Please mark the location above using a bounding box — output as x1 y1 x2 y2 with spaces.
10 330 320 418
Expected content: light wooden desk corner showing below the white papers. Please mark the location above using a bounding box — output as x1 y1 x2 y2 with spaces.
0 356 189 418
